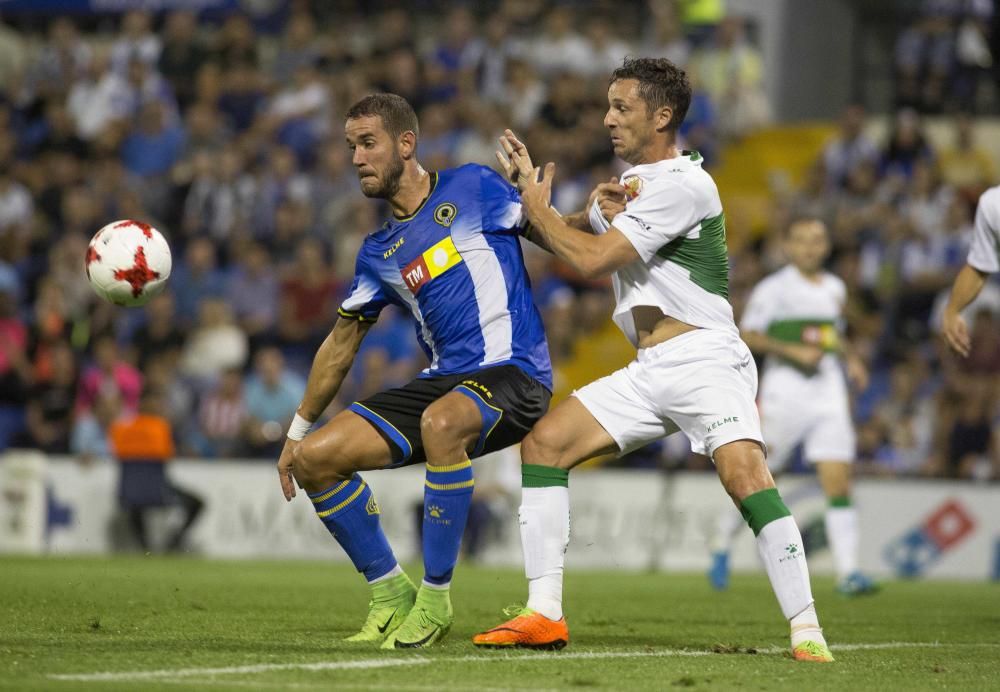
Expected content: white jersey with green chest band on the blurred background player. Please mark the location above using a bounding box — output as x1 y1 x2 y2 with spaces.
740 265 847 402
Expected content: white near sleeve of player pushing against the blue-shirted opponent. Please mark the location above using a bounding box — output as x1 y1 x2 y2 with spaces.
611 181 700 262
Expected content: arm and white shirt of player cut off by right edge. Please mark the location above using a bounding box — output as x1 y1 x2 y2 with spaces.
944 185 1000 357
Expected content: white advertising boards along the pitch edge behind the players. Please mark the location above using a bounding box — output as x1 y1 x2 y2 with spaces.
0 452 1000 579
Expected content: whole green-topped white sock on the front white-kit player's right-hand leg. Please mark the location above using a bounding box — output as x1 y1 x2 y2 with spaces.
740 488 813 620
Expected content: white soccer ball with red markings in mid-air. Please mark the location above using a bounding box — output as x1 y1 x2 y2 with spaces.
84 219 171 307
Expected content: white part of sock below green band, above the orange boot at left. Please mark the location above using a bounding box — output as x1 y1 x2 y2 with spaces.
518 486 569 620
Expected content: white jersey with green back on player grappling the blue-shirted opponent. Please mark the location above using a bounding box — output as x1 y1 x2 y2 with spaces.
590 151 738 346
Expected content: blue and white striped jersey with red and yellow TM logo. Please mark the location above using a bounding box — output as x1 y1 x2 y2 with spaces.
340 164 552 389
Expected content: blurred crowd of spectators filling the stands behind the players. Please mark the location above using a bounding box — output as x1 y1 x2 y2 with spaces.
0 0 1000 479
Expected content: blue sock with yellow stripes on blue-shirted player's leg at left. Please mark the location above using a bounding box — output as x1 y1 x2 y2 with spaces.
309 474 397 582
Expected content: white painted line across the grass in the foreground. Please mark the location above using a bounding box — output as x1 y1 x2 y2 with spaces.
48 642 1000 682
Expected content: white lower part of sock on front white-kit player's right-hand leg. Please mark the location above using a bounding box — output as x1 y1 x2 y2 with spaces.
757 515 813 620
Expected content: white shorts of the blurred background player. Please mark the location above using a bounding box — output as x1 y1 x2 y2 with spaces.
760 393 856 471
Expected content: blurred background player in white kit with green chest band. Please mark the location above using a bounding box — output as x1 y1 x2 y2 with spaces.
708 219 877 596
